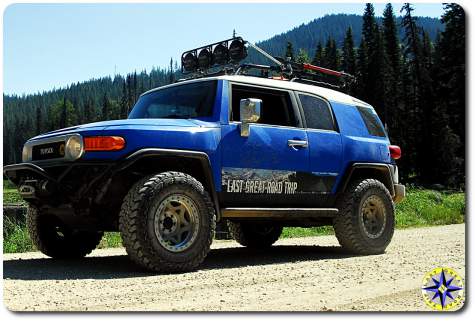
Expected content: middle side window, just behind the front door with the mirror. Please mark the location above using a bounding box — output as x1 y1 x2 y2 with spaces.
299 94 335 130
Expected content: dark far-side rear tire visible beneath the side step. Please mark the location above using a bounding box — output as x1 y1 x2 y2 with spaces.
228 221 282 248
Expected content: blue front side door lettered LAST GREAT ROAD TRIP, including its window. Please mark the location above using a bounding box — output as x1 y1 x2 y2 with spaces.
220 84 309 207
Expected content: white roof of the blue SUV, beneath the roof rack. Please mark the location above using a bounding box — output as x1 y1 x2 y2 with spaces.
144 75 371 107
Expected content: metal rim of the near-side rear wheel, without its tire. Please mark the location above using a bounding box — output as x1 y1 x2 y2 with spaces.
360 195 387 239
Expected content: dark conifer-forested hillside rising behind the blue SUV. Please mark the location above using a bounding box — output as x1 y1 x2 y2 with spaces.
3 4 466 188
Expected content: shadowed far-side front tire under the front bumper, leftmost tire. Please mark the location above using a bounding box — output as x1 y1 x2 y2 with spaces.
26 206 104 259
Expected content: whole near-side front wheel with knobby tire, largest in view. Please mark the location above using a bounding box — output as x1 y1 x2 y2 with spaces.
119 172 216 272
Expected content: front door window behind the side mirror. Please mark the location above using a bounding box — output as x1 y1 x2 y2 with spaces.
231 85 297 127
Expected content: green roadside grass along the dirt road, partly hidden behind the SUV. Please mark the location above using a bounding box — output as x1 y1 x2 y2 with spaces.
3 181 465 253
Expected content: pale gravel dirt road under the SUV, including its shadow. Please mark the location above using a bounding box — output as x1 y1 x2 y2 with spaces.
3 224 465 311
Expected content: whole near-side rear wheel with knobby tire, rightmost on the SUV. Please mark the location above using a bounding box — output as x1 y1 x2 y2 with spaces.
333 179 395 254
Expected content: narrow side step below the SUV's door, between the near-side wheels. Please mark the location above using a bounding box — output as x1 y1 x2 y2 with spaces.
221 207 338 219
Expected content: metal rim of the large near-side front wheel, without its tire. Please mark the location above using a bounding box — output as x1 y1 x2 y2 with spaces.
154 194 199 253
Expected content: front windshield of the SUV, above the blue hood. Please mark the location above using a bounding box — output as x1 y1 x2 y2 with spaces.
129 80 216 119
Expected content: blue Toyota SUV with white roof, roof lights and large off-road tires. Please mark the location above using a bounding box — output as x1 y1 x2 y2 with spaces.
4 38 405 272
